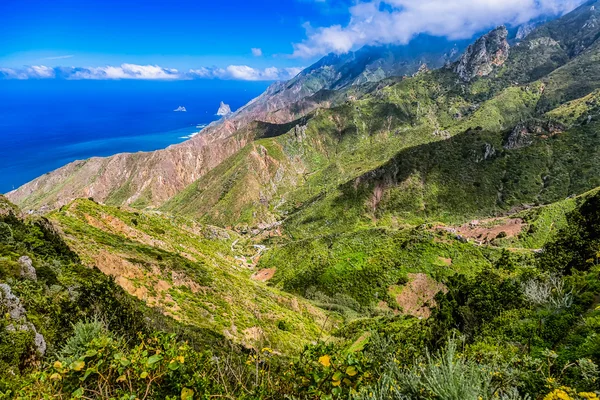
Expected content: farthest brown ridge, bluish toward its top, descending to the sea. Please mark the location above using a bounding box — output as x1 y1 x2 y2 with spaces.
7 34 464 210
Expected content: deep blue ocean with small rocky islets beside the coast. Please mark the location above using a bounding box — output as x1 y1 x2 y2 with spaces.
0 80 269 193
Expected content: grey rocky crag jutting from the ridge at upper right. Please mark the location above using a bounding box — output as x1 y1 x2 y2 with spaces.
454 26 510 82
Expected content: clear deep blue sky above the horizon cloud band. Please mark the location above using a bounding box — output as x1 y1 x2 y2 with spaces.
0 0 348 68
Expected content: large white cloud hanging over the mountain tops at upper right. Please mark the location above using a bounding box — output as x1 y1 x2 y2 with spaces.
293 0 585 57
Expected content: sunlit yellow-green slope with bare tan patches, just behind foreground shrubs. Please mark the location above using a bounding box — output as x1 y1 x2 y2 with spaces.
48 200 333 350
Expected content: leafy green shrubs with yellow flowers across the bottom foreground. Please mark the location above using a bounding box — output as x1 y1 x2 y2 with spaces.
4 194 600 400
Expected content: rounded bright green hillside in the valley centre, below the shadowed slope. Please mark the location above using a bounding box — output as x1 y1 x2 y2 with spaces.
259 228 499 311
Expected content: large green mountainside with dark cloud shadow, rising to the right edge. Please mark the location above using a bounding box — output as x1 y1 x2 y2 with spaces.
163 2 600 232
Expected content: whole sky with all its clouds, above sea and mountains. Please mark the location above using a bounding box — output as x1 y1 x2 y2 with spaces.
0 0 583 80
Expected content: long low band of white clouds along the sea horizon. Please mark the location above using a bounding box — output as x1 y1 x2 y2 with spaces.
0 64 302 81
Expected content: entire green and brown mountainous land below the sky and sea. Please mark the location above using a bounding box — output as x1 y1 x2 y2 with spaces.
0 1 600 400
